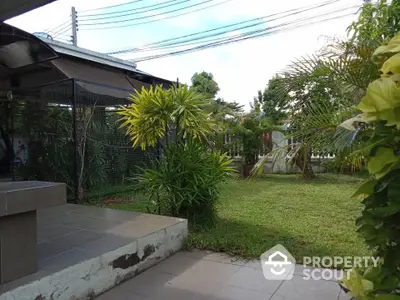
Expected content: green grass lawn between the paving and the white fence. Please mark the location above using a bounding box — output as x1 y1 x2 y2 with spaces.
93 174 369 259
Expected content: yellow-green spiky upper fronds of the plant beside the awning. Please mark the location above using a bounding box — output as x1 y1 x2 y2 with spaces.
118 85 212 150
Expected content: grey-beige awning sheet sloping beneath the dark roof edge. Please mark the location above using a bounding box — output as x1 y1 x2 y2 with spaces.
52 57 149 99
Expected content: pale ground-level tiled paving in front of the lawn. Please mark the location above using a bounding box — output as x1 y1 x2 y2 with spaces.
96 251 350 300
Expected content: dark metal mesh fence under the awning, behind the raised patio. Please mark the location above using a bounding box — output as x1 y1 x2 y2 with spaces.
0 79 157 200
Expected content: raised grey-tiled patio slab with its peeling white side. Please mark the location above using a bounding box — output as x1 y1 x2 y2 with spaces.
0 204 187 300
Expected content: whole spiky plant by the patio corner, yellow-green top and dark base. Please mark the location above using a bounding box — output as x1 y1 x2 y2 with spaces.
119 86 233 223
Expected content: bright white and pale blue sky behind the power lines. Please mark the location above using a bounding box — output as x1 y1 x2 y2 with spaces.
7 0 363 109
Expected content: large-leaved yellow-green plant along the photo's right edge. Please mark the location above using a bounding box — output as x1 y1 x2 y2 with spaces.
343 34 400 300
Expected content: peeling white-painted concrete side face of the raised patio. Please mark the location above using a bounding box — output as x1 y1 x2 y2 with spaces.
0 220 188 300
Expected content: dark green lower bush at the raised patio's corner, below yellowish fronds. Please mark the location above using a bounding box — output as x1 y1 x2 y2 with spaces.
138 140 234 223
